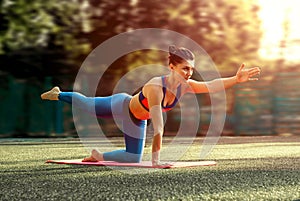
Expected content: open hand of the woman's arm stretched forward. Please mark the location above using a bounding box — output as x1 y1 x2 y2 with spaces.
236 64 260 83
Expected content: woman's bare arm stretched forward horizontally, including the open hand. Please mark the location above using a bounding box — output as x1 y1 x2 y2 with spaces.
188 64 260 93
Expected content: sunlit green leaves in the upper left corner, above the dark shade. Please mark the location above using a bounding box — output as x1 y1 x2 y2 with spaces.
0 0 89 54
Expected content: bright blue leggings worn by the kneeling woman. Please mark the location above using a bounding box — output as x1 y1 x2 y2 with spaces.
58 92 147 163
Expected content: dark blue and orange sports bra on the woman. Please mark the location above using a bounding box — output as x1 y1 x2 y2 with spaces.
139 76 181 112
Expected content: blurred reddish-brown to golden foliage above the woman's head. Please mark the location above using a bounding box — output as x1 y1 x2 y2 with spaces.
83 0 261 75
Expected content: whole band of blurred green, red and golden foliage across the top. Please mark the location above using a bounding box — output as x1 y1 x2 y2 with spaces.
0 0 261 77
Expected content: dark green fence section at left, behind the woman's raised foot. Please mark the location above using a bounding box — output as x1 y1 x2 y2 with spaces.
0 75 74 137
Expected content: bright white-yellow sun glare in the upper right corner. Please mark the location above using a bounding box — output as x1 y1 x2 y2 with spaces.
259 0 300 62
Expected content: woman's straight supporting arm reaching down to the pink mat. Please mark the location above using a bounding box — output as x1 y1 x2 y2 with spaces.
143 81 164 166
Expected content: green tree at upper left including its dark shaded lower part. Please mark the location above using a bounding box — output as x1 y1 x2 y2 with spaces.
0 0 90 77
